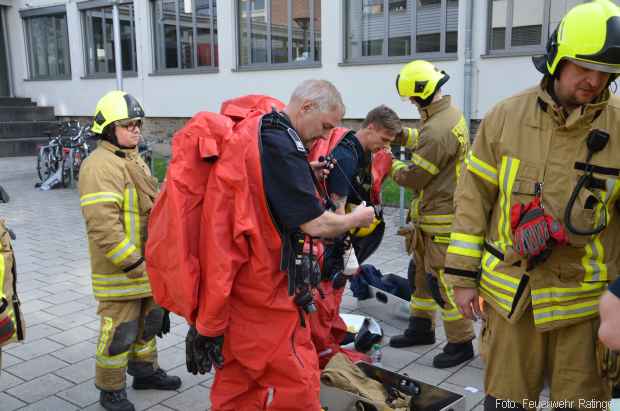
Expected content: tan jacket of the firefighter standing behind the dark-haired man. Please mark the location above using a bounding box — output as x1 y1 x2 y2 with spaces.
392 96 469 234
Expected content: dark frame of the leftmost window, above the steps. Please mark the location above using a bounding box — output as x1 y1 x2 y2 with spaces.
19 5 72 81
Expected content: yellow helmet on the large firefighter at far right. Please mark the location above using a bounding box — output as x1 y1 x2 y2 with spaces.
533 0 620 75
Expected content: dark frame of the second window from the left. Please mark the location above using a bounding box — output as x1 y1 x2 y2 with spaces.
77 0 138 80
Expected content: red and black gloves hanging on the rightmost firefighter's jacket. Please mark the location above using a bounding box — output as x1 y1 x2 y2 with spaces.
510 197 567 259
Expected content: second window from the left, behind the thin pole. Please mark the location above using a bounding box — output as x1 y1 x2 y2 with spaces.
78 2 138 77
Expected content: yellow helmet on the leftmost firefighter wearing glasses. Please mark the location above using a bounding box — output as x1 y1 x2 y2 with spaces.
91 90 144 134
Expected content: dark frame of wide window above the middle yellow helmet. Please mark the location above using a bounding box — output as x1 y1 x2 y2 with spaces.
338 0 463 66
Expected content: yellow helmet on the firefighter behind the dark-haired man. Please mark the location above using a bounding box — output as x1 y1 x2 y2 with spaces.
396 60 450 100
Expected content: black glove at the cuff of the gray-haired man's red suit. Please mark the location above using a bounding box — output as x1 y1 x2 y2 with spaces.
185 327 224 375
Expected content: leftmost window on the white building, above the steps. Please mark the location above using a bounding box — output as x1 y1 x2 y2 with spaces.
21 6 71 80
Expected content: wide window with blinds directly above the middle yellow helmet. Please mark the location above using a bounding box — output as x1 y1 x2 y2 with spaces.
345 0 459 63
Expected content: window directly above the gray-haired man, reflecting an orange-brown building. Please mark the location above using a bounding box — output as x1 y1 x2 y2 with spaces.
237 0 321 68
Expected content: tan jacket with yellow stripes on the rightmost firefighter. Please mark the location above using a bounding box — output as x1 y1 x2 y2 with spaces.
446 82 620 329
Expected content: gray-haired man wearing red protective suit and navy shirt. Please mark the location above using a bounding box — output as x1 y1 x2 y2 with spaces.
186 80 374 411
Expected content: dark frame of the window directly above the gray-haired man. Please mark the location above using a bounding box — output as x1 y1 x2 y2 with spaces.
233 0 323 71
